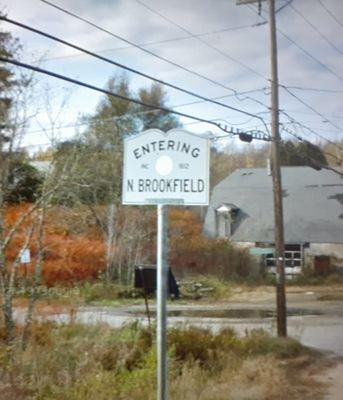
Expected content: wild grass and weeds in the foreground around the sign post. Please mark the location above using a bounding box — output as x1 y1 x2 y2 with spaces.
0 323 323 400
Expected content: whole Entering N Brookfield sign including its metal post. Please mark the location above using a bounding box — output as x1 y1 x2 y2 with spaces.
122 129 209 400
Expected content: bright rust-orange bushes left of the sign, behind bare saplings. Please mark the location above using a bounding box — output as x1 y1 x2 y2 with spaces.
6 204 105 286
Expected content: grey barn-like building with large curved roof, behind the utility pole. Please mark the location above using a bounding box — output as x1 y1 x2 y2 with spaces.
204 167 343 274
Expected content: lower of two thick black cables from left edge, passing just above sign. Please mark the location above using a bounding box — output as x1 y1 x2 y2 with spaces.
0 57 271 142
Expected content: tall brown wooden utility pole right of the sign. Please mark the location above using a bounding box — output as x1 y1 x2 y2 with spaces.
237 0 287 336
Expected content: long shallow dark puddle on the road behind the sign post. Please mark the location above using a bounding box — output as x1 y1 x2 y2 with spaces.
135 308 322 319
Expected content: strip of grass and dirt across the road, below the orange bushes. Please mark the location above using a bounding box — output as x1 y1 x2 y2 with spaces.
16 275 343 307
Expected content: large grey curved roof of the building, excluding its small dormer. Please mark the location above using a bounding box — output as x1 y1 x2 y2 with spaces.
204 167 343 243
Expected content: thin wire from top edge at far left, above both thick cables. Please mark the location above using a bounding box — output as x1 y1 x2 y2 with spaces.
39 0 268 118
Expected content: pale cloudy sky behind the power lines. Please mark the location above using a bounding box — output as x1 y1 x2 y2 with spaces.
0 0 343 150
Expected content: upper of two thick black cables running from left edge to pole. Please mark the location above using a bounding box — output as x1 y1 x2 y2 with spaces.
0 16 268 132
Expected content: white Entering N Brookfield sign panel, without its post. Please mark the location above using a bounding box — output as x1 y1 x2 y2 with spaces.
123 129 209 206
